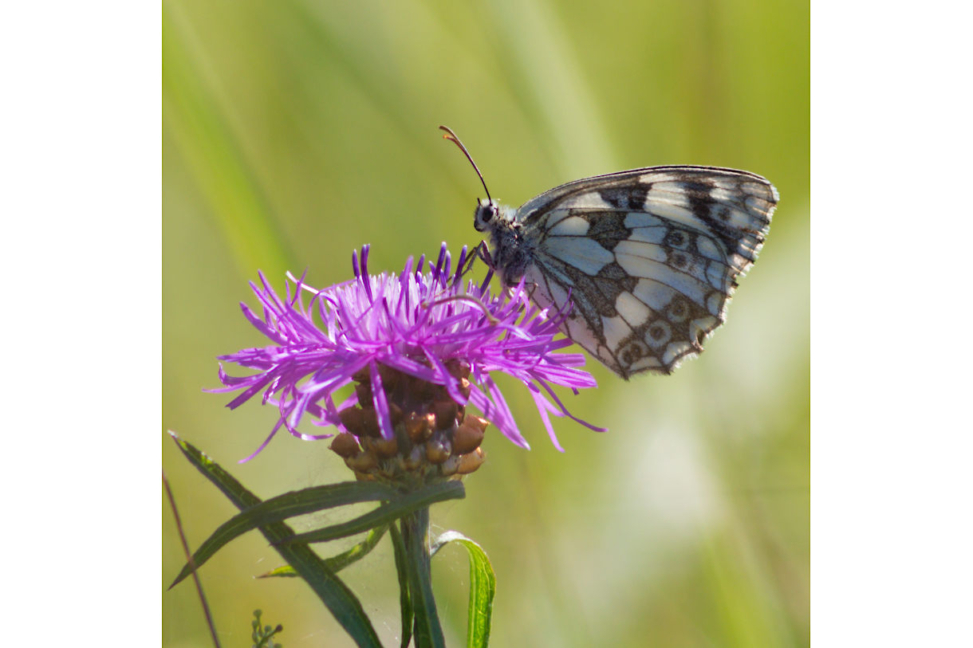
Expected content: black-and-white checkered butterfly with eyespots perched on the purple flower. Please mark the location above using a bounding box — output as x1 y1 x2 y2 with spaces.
440 126 779 380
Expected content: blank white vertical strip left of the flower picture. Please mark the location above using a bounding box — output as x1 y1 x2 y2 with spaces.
0 2 163 646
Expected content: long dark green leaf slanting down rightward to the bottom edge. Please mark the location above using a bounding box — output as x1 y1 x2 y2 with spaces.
169 432 382 648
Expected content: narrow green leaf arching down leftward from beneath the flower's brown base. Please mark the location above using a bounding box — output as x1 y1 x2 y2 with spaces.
169 482 398 589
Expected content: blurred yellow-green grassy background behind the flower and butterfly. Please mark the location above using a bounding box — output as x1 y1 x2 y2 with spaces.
162 0 810 648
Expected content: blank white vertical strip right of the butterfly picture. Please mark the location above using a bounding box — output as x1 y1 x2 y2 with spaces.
811 2 973 647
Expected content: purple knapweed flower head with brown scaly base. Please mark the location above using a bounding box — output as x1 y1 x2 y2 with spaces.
213 243 603 481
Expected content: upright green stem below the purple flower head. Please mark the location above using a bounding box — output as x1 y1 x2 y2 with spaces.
402 508 446 648
